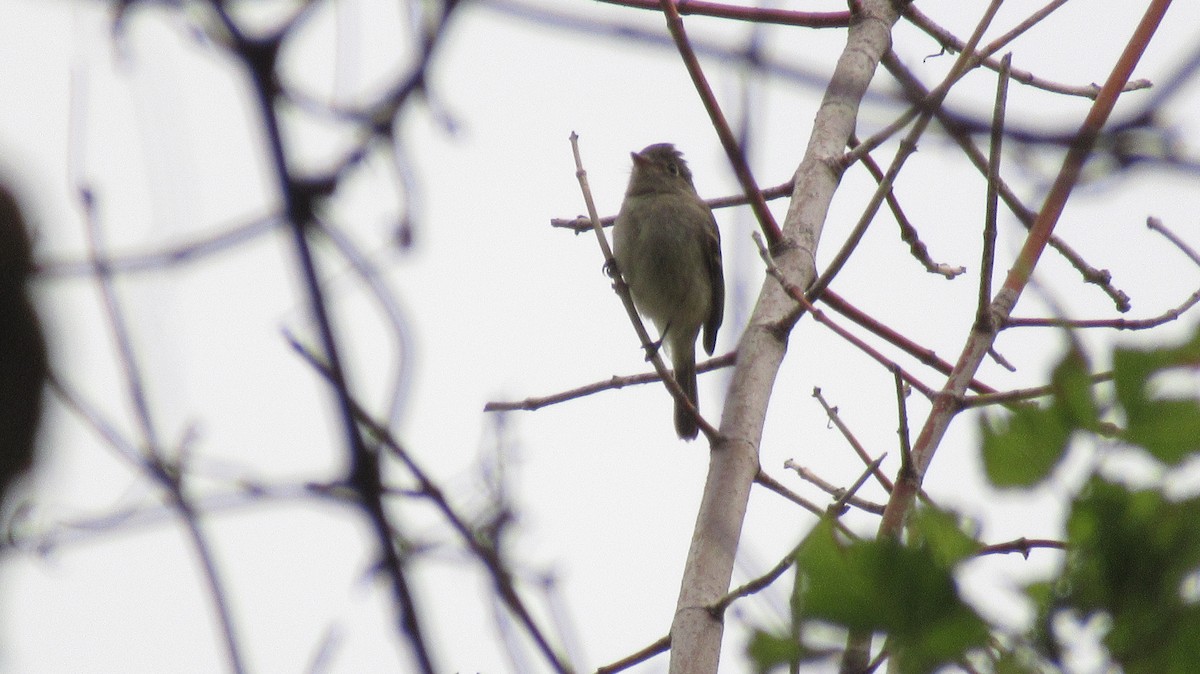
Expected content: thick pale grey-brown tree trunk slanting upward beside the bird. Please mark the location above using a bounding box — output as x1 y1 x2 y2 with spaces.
671 0 899 674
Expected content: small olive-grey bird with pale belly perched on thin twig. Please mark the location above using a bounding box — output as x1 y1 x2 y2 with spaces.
612 143 725 440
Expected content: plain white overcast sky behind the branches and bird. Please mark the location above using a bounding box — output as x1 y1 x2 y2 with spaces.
0 0 1200 673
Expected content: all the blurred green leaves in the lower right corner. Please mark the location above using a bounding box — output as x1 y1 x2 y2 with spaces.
748 323 1200 674
